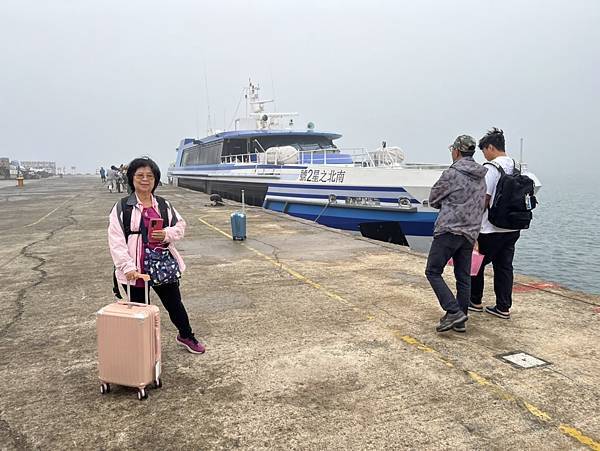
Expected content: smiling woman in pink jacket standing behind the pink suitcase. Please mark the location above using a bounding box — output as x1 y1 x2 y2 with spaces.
108 158 205 354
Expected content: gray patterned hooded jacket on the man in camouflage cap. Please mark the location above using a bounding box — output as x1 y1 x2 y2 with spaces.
429 157 487 243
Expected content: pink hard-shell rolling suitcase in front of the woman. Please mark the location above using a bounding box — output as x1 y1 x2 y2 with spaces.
96 279 162 401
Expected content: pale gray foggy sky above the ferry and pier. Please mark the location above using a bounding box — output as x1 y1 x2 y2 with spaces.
0 0 600 182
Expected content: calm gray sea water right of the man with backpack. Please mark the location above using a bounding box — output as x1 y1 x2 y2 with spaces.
514 174 600 294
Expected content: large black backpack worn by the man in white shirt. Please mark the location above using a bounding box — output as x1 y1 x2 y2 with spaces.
484 160 537 230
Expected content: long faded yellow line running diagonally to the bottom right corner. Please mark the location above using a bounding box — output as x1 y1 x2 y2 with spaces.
198 218 600 451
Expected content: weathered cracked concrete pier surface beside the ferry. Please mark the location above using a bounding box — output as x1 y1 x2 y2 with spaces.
0 177 600 450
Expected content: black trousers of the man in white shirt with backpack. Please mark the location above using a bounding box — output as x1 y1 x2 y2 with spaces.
471 231 521 312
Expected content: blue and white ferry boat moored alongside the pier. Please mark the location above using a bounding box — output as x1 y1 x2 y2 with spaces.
168 82 528 251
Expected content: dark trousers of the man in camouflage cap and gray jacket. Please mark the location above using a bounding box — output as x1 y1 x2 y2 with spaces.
425 233 473 313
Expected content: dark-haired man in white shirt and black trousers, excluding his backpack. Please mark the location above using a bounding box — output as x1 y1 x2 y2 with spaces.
469 127 520 319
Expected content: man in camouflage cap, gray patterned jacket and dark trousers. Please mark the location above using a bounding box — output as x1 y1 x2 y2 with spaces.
425 135 487 332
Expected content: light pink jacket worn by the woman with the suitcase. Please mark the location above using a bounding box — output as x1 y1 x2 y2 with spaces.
108 193 186 283
